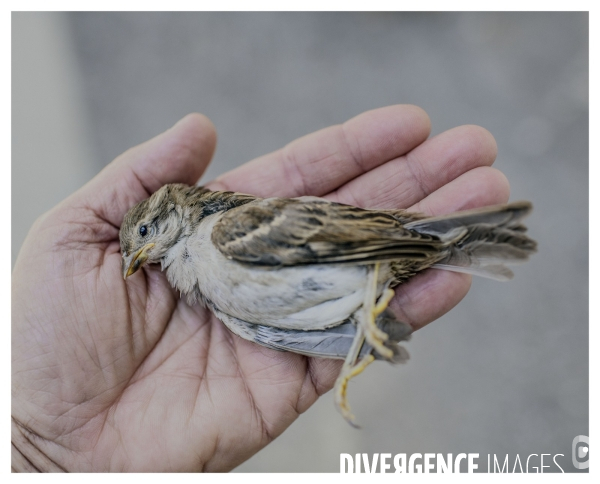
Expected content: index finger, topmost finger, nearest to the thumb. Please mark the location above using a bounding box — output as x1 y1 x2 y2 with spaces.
207 105 430 197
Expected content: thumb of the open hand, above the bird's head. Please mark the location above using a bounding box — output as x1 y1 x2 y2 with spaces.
77 114 216 227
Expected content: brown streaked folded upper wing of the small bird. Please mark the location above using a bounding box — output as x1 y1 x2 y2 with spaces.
212 197 447 267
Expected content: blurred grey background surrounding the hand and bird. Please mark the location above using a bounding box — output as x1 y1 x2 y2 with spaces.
12 13 589 472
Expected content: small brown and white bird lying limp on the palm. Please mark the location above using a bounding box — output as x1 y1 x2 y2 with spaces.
119 184 536 425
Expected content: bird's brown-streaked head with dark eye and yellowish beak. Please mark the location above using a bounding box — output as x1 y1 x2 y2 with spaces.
119 185 189 279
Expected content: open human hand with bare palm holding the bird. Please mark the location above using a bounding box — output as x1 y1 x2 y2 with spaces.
12 105 509 471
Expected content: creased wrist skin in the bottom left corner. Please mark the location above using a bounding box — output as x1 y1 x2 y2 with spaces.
11 417 65 472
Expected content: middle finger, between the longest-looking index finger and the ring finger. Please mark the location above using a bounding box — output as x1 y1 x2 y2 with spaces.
326 126 497 208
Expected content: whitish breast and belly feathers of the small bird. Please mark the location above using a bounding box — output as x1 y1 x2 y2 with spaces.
165 214 388 330
